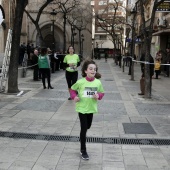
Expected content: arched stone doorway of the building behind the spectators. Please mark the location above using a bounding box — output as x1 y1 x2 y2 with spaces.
36 24 64 51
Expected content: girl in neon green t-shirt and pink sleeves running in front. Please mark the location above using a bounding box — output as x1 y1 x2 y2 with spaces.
71 60 104 160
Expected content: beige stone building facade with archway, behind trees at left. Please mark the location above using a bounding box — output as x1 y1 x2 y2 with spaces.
0 0 92 57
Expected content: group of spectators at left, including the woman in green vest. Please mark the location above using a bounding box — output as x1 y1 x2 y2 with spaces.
18 43 65 86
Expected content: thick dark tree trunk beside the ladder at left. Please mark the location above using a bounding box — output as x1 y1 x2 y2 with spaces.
8 0 28 93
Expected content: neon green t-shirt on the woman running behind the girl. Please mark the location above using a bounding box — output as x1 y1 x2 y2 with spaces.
63 54 80 72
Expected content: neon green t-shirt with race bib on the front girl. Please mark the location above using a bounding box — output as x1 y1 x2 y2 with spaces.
71 78 104 114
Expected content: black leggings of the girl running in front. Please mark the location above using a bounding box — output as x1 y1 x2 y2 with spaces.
79 113 93 151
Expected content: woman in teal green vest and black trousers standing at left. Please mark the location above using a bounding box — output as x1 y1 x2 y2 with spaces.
38 47 53 89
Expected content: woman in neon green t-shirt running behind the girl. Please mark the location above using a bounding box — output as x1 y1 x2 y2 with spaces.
63 46 80 100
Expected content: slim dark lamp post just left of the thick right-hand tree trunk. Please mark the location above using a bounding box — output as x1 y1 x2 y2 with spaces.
129 4 137 80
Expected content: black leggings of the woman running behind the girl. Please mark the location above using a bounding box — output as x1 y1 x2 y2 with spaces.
66 71 78 89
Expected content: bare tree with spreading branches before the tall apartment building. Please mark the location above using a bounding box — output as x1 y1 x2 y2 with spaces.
95 0 126 60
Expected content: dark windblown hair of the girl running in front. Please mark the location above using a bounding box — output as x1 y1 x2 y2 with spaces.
81 59 101 79
